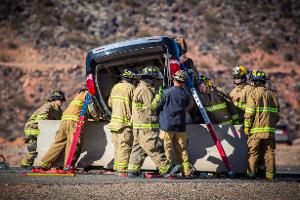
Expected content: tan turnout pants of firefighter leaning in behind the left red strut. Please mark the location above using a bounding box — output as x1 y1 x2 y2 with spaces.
40 120 82 169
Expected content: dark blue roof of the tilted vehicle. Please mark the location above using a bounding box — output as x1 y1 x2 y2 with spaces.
86 36 179 73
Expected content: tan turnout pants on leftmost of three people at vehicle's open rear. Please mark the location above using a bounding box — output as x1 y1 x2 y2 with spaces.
111 127 133 173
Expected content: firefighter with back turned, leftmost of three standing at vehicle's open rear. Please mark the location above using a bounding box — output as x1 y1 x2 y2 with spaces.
108 69 136 176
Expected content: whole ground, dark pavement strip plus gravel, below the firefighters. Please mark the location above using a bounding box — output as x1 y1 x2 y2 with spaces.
0 170 300 200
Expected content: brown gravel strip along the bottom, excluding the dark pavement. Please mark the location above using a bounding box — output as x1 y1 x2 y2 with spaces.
0 179 300 200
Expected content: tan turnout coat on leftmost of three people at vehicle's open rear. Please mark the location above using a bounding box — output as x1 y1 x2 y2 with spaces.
108 81 134 131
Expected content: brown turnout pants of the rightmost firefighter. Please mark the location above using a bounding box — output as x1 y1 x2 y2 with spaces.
247 133 276 179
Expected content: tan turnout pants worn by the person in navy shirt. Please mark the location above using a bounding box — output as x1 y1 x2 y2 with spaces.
160 130 192 176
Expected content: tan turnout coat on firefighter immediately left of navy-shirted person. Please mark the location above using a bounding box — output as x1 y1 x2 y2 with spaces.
131 81 162 130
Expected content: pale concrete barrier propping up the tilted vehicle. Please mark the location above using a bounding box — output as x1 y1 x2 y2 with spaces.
35 120 247 172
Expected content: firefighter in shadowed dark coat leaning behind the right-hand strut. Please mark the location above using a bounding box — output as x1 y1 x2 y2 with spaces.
198 75 237 125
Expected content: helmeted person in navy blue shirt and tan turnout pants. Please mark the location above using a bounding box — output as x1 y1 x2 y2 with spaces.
159 70 193 178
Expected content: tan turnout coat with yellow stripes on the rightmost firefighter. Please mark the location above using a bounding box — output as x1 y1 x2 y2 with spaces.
244 86 279 134
